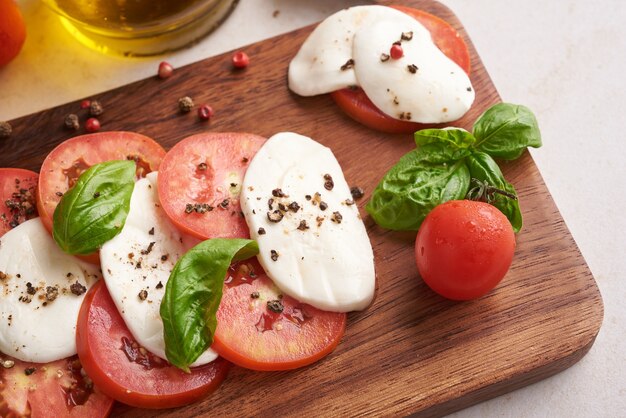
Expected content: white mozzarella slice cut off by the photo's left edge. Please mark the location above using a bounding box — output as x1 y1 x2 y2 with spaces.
0 218 99 363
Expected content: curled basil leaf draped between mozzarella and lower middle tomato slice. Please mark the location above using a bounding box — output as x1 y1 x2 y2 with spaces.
160 238 259 372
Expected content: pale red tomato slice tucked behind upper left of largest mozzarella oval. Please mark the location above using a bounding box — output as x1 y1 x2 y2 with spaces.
158 132 267 239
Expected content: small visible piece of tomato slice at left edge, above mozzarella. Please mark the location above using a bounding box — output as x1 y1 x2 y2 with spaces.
0 168 38 236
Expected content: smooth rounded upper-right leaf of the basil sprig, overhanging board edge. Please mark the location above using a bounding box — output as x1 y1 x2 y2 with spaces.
473 103 541 160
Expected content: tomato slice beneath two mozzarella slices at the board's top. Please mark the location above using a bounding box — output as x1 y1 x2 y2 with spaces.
330 6 470 133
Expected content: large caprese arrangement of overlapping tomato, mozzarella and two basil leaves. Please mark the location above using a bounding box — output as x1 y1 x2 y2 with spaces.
0 132 375 417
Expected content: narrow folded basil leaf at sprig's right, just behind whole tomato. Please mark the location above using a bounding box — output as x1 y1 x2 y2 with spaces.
466 152 522 233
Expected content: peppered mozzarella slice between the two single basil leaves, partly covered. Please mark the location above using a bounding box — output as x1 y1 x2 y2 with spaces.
100 172 217 367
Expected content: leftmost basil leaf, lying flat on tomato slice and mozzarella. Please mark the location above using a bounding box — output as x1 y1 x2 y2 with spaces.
52 161 135 254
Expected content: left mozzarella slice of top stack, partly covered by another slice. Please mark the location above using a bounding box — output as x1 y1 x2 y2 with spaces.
288 6 410 96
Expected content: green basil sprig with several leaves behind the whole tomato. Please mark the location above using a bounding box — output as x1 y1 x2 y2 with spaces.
365 103 541 232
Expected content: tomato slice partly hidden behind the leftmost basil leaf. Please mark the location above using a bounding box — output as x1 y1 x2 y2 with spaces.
37 132 165 238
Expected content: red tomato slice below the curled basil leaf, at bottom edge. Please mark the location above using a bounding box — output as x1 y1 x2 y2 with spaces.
76 280 230 408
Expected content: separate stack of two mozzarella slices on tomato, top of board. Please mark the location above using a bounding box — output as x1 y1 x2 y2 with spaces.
288 5 475 133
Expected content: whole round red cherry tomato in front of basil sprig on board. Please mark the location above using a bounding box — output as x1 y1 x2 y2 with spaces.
415 200 515 300
